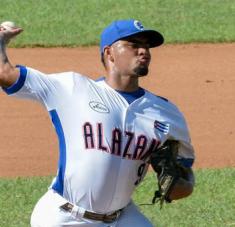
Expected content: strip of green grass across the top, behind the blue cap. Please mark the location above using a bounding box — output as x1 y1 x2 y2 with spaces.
0 0 235 47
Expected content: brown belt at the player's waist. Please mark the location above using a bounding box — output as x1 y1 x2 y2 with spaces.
60 203 122 223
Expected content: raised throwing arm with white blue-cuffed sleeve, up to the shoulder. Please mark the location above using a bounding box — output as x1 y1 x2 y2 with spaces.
0 26 74 110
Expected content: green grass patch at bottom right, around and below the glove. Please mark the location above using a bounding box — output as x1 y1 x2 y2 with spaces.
134 168 235 227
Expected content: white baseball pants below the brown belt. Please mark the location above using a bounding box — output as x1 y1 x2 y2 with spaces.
31 190 153 227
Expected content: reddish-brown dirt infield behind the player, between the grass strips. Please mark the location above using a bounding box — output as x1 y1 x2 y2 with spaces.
0 43 235 177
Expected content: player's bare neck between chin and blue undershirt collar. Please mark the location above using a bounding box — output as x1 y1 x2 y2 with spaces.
105 76 139 92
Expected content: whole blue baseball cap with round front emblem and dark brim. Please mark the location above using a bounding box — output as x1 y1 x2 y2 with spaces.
100 19 164 54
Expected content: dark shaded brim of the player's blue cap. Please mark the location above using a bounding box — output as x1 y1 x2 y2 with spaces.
119 30 164 48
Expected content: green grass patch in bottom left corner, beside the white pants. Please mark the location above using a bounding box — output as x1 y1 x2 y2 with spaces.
0 177 51 227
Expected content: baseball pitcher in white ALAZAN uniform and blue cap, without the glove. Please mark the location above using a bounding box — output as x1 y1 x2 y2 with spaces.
0 19 194 227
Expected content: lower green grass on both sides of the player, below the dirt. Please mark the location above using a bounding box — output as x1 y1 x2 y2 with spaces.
0 168 235 227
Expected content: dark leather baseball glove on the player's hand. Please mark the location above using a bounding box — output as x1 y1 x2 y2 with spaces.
150 140 183 208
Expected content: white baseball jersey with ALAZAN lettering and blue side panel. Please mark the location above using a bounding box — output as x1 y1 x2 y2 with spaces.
5 66 194 213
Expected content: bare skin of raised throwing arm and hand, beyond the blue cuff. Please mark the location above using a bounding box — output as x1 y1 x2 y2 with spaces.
0 27 23 88
